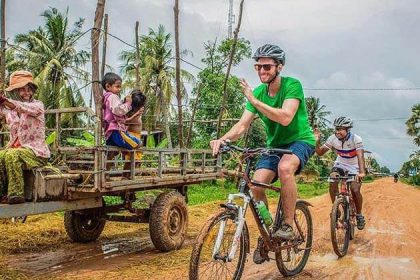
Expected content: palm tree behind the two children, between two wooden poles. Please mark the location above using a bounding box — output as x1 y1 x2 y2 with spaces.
120 25 194 147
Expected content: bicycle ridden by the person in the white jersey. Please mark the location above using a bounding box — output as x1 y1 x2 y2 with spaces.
328 171 356 257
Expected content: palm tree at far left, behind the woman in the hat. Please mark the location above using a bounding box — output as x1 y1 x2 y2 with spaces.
11 8 90 127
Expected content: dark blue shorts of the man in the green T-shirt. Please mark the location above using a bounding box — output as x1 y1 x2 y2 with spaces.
255 141 315 180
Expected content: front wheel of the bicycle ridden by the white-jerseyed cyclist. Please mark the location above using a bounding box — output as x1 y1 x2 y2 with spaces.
331 197 351 257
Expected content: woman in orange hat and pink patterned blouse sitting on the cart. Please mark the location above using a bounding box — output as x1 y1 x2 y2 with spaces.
0 71 50 204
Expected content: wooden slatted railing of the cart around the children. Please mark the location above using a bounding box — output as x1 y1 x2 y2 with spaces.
0 107 221 199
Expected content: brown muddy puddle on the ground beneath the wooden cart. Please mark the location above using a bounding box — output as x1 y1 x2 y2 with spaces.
8 238 153 274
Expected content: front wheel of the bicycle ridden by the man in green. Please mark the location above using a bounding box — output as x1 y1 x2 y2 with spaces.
189 209 249 280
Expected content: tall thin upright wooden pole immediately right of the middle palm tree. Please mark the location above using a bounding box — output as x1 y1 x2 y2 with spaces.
174 0 184 148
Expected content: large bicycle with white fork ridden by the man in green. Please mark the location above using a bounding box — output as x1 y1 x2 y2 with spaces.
189 145 313 280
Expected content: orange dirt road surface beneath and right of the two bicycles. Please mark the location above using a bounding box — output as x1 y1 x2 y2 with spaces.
243 178 420 279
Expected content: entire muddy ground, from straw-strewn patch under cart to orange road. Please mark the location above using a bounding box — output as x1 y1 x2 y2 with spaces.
0 178 420 279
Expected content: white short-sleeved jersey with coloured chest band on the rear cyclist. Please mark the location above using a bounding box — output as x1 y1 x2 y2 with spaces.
324 132 363 170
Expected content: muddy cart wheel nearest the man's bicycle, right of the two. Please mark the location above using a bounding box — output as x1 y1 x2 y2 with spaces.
149 192 188 252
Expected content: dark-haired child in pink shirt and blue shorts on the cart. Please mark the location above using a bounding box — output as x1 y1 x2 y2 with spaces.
102 73 141 173
